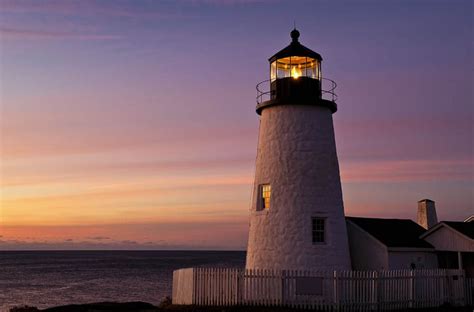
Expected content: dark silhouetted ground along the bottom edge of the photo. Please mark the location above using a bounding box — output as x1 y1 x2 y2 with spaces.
10 301 474 312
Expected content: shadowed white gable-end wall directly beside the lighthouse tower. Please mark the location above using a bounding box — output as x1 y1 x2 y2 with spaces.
347 221 389 270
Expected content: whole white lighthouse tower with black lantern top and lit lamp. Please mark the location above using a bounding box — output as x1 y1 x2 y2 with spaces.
246 29 351 270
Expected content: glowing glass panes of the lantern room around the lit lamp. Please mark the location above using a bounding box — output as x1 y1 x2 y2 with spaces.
270 56 321 81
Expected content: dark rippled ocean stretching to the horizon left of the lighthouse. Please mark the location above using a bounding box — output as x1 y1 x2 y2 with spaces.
0 251 245 312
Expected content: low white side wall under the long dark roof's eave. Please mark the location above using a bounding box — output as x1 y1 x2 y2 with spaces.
388 251 438 270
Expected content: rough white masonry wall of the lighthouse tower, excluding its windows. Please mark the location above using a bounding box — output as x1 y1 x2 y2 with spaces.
246 105 350 270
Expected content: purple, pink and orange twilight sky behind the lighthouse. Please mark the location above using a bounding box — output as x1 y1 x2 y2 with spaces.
0 0 474 250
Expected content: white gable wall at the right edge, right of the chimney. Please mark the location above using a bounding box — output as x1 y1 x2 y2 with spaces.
424 225 474 252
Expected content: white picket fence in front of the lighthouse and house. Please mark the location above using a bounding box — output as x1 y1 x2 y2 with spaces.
173 268 474 311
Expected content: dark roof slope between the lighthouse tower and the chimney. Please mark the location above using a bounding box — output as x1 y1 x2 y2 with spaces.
346 217 434 248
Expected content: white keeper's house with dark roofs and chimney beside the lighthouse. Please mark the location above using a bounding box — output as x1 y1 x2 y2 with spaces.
346 199 474 277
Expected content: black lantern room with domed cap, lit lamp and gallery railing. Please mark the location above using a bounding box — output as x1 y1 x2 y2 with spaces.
257 29 337 114
